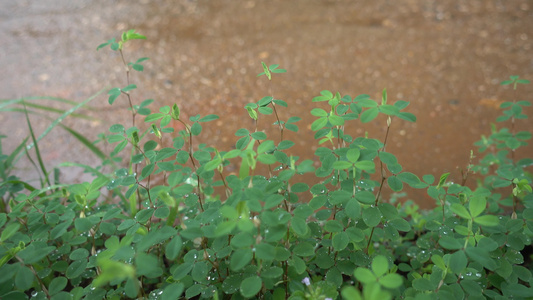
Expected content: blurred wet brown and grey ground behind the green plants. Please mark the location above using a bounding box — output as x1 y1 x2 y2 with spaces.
0 0 533 207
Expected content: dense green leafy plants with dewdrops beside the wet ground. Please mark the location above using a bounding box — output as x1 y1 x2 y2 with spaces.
0 30 533 300
